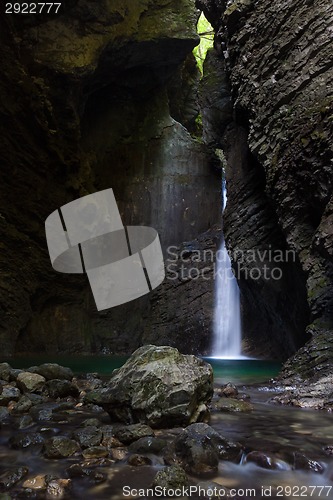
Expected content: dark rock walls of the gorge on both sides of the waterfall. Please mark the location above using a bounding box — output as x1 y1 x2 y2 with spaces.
0 0 333 378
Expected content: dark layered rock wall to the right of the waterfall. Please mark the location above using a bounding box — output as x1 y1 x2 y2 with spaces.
197 0 333 368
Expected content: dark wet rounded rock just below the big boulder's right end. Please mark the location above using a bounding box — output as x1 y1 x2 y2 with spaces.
174 423 242 476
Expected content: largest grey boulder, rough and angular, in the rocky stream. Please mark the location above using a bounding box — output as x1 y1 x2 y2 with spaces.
86 345 213 427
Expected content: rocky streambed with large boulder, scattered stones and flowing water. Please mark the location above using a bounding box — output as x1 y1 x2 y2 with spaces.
0 346 333 500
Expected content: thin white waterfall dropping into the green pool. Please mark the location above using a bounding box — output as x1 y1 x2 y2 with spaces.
212 181 242 358
